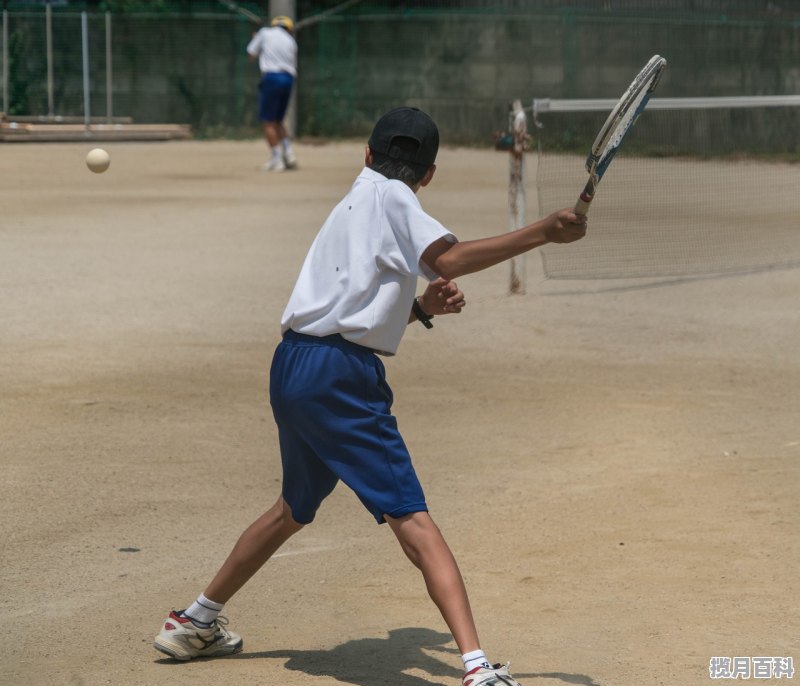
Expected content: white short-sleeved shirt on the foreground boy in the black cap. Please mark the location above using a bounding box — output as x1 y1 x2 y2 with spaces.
281 167 457 355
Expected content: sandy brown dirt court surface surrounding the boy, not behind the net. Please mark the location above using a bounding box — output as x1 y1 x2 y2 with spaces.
0 140 800 686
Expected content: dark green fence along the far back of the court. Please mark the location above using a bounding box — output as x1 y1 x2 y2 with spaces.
0 0 800 144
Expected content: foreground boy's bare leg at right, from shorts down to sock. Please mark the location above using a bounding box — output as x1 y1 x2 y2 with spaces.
386 512 480 655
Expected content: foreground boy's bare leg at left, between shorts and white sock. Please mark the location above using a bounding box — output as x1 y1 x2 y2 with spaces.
203 497 303 604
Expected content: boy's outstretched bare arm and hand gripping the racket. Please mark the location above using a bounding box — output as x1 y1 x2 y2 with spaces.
422 209 586 284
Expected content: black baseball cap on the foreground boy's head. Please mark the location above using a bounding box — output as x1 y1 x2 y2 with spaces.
369 107 439 167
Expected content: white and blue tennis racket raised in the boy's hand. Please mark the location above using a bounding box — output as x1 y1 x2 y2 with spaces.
575 55 667 214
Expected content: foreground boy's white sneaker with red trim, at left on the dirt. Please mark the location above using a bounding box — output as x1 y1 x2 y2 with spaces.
153 610 242 660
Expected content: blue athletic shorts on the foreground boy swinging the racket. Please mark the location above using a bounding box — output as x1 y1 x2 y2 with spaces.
269 331 428 524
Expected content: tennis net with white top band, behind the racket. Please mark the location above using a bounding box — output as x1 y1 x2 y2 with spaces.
530 96 800 279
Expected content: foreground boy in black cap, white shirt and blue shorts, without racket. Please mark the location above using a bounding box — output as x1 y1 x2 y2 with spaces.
155 107 586 686
